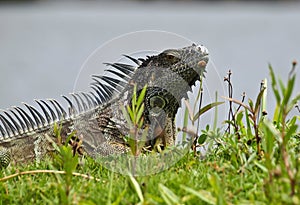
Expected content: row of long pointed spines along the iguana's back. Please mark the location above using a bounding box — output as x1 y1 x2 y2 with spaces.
0 55 141 143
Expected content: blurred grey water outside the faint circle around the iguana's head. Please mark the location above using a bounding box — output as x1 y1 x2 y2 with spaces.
0 1 300 127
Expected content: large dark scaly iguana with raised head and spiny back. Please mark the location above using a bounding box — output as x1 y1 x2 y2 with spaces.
0 44 208 167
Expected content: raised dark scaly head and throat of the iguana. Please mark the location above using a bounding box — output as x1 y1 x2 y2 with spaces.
119 44 208 147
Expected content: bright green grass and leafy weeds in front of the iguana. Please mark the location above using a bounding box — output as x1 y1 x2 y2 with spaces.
0 65 300 204
